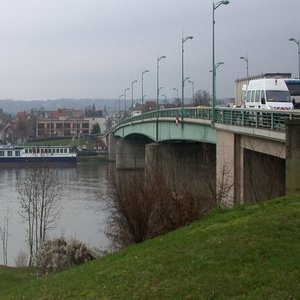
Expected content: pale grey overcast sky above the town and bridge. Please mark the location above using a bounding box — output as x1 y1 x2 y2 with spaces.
0 0 300 101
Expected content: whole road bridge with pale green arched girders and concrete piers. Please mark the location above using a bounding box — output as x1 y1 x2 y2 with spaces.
107 107 300 205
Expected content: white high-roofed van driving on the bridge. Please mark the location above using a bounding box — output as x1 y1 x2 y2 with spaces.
244 78 294 110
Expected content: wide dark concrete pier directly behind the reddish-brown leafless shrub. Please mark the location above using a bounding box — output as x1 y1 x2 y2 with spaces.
145 142 216 193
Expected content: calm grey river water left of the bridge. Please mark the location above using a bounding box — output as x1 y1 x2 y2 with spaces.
0 160 114 266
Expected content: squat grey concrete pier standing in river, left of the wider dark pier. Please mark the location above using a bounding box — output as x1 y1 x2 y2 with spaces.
116 139 149 170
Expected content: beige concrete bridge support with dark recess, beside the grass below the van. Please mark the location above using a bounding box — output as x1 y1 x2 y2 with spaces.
216 130 286 206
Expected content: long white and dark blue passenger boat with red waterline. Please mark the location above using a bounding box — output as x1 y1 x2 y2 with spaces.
0 146 77 167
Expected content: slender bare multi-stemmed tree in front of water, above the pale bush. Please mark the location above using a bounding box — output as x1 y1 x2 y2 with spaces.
17 162 62 265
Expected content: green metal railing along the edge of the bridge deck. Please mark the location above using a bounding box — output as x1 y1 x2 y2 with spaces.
115 107 300 131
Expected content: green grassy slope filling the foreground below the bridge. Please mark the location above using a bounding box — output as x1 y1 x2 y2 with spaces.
0 195 300 299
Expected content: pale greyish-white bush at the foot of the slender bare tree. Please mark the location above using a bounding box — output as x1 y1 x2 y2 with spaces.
35 237 104 277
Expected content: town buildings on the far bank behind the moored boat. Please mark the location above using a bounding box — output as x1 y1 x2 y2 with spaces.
0 106 106 145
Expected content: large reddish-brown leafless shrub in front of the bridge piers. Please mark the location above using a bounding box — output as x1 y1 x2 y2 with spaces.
106 146 213 248
